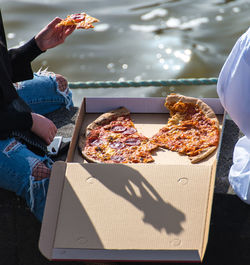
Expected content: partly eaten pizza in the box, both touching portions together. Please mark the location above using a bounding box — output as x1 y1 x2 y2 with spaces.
79 94 220 163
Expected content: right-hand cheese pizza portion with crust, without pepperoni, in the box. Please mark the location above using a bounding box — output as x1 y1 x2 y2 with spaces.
152 94 220 163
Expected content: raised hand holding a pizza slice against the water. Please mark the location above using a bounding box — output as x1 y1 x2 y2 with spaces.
35 17 76 51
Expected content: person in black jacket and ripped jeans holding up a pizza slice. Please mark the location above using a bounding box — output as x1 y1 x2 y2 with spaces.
0 9 75 221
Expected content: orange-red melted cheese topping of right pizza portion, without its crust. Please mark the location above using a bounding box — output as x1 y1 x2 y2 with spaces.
153 102 219 156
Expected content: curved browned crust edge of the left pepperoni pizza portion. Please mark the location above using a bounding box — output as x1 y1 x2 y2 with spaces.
78 107 130 163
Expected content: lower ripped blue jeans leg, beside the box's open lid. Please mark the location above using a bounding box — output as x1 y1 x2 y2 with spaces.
0 138 53 221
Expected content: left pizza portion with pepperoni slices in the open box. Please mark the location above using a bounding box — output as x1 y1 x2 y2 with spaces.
79 107 157 163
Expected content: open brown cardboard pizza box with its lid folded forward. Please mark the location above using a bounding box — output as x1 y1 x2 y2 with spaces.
39 98 224 262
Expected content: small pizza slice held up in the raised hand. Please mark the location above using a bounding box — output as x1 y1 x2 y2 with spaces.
57 12 99 29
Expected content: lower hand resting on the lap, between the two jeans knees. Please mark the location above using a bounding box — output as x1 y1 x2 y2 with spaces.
31 113 57 145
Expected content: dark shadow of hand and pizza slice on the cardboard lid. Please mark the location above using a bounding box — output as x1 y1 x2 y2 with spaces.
82 164 185 235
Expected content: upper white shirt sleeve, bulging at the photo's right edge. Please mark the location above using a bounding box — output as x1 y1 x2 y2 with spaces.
217 28 250 139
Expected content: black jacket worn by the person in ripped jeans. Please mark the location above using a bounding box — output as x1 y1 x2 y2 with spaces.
0 10 42 135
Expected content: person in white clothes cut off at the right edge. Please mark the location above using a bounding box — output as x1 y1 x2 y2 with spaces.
217 28 250 203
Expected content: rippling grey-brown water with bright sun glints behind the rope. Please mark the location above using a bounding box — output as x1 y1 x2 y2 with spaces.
0 0 250 105
